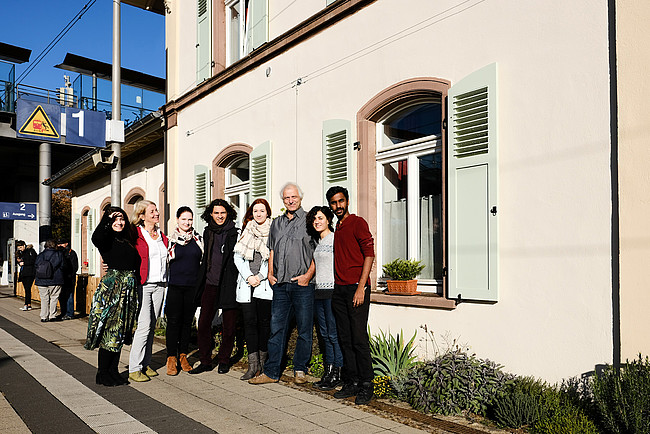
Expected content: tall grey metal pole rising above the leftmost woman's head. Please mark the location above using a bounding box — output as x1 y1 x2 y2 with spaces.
111 0 122 206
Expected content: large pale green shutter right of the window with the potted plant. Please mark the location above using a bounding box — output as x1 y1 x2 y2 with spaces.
447 63 499 301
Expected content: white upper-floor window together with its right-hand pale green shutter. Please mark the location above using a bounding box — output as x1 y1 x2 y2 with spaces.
225 0 268 65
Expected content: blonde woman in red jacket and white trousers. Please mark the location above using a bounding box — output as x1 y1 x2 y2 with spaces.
129 200 167 382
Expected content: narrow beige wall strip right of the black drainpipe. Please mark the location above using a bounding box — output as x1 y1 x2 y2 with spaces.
616 1 650 361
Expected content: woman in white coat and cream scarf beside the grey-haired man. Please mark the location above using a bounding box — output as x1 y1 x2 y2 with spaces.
234 199 273 380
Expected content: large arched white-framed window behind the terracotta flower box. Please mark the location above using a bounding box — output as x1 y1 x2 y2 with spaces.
376 96 443 292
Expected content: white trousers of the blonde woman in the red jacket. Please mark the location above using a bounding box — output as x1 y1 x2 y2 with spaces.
129 283 166 372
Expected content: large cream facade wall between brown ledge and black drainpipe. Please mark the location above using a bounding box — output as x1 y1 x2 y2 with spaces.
169 0 613 381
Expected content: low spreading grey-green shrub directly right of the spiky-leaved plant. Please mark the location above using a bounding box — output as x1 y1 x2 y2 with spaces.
405 351 512 415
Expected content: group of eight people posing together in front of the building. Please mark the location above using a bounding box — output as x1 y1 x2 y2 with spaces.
85 183 374 404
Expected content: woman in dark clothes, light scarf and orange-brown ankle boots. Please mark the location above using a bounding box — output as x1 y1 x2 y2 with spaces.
165 206 203 375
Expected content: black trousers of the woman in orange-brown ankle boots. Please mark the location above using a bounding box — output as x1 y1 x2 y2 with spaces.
165 285 196 357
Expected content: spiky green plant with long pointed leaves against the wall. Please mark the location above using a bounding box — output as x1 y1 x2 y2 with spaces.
368 330 417 377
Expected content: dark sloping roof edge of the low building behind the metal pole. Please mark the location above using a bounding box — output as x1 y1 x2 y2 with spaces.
43 111 164 188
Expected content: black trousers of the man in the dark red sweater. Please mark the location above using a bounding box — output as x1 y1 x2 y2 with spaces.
332 285 374 383
